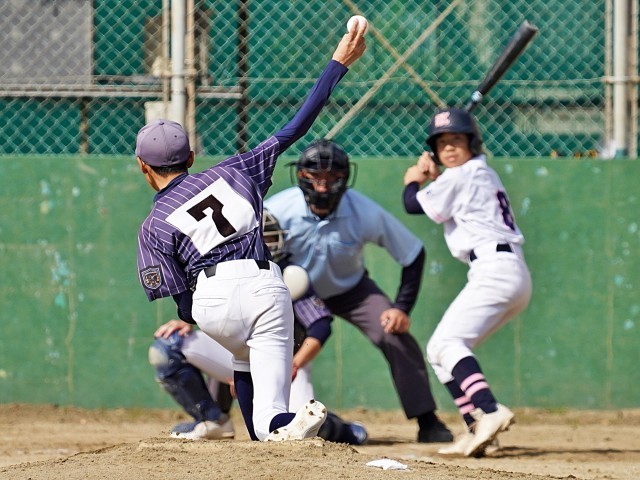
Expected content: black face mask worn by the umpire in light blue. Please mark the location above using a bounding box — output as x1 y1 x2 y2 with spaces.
289 139 357 213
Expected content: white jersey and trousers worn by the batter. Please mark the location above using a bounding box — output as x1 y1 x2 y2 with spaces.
416 155 532 384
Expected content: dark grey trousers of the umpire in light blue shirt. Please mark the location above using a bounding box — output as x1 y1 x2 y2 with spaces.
323 274 436 418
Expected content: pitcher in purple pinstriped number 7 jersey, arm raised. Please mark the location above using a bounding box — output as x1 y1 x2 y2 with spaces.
131 22 366 440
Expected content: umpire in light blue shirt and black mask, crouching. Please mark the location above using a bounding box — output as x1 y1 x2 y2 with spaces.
265 140 453 443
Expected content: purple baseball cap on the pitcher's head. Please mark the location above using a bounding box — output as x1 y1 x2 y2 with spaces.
136 119 191 167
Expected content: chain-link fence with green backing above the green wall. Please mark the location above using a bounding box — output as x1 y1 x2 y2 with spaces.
0 0 638 156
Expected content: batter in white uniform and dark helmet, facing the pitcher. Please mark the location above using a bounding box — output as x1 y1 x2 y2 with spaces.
404 108 532 456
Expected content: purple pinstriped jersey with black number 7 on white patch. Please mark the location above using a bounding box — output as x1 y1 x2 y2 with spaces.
138 137 280 300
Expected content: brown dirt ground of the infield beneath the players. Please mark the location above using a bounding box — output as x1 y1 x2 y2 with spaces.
0 404 640 480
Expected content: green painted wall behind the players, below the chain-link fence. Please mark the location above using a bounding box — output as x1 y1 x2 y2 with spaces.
0 156 640 410
